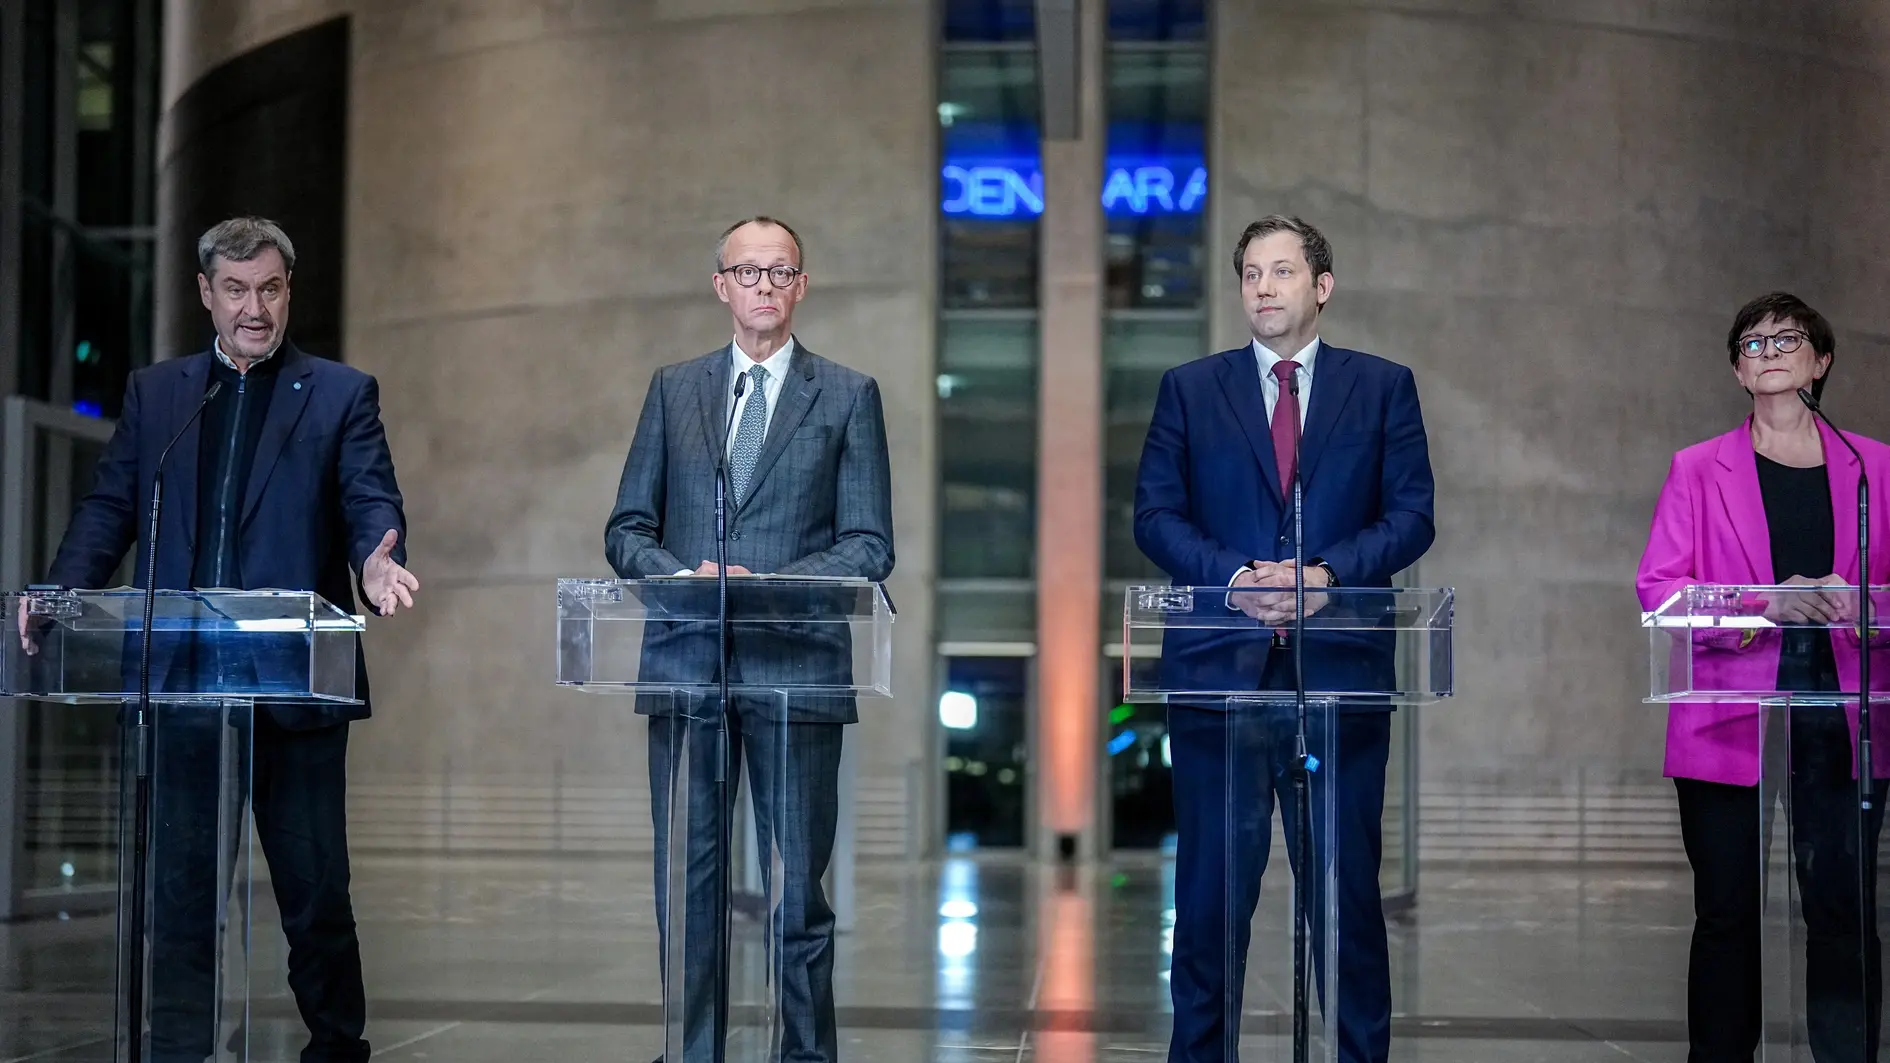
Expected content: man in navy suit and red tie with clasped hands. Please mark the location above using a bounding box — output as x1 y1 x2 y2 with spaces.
1136 216 1435 1063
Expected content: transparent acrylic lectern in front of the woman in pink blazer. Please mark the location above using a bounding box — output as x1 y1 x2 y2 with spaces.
1642 584 1890 1063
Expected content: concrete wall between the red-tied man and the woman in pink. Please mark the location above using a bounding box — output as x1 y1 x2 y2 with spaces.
1211 0 1890 804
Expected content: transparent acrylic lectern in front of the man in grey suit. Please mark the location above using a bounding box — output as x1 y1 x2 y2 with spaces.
558 577 892 1063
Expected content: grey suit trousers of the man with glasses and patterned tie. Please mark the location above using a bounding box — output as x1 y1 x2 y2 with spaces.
650 702 845 1063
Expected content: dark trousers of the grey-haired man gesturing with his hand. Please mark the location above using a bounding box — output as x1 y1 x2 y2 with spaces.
149 706 369 1063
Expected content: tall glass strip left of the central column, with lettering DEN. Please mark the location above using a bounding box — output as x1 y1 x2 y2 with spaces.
937 0 1043 849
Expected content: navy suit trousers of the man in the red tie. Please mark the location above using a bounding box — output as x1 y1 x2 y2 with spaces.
1168 692 1391 1063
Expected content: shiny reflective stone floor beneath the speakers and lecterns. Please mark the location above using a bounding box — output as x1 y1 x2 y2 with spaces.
0 857 1716 1063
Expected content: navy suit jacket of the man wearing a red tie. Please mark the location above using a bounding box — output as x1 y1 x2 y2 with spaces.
1136 344 1436 703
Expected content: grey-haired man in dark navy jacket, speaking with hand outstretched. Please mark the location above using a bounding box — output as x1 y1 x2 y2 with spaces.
19 218 420 1063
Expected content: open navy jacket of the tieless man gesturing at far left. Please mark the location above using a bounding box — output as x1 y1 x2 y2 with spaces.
47 342 406 728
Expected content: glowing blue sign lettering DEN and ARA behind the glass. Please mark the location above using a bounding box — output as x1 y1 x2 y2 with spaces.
939 157 1208 218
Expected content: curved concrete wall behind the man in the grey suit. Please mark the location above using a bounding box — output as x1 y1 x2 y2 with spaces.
166 0 936 849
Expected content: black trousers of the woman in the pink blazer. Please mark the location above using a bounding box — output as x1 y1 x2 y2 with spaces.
1675 709 1886 1063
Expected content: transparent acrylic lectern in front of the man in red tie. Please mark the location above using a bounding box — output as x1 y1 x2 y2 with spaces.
1123 586 1455 1063
